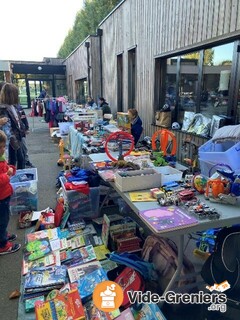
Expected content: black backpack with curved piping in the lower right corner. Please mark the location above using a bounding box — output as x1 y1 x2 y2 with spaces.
201 225 240 294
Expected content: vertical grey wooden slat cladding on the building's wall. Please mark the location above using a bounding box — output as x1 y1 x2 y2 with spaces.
66 0 240 160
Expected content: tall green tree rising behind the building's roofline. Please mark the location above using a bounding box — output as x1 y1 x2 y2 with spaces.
58 0 120 58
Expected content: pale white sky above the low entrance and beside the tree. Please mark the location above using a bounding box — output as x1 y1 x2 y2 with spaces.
0 0 83 61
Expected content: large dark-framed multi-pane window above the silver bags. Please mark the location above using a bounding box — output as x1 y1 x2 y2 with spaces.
154 41 236 123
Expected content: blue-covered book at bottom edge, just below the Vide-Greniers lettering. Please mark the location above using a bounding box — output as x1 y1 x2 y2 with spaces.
131 303 166 320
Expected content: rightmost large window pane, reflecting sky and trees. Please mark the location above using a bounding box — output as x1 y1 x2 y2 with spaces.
200 43 234 117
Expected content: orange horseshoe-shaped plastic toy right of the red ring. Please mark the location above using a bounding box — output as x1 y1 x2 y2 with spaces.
152 129 177 156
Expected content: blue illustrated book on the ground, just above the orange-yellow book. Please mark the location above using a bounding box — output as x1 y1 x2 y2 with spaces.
24 266 67 292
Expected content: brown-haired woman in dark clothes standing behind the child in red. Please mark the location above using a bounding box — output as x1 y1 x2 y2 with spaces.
0 83 25 169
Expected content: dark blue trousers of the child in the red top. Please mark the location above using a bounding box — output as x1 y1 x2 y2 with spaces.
0 197 10 248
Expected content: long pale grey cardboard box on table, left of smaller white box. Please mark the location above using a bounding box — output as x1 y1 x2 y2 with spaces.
115 169 161 192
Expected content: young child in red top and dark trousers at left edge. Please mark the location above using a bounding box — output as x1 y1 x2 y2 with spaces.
0 130 21 255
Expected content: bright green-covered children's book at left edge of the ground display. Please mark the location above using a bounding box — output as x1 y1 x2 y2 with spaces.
23 238 52 261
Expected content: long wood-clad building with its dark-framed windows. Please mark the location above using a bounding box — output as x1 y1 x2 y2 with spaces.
64 0 240 135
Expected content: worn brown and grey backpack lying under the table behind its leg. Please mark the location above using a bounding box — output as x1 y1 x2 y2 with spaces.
142 236 196 294
